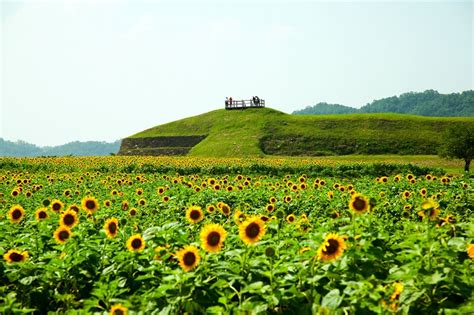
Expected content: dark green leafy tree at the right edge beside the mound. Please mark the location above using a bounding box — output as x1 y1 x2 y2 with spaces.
440 124 474 172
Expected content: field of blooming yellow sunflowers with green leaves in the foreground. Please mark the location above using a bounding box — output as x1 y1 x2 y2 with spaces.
0 157 474 314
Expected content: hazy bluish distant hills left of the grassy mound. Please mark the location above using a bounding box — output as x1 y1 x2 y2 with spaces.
0 138 120 157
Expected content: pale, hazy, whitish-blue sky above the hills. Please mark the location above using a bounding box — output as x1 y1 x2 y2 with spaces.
0 0 474 146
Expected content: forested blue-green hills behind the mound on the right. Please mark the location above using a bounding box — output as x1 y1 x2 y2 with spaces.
293 90 474 117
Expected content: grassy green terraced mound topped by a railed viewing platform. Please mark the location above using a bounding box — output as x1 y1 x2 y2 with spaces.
119 108 474 157
